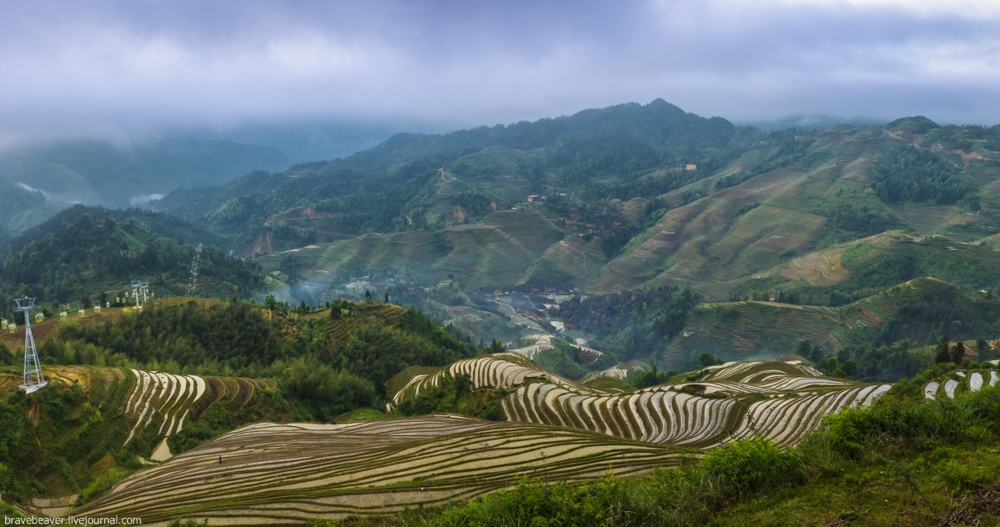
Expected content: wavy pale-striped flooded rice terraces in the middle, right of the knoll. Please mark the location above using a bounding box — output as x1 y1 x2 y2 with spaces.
393 353 891 449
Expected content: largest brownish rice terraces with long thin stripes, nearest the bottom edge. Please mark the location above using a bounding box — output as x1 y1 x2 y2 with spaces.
73 416 685 525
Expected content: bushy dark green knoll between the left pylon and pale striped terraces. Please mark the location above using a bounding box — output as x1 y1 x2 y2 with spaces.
33 299 474 420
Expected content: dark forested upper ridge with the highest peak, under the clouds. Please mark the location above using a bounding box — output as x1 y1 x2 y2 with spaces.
158 100 762 252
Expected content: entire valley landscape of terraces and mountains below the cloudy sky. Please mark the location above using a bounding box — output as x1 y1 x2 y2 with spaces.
0 100 1000 525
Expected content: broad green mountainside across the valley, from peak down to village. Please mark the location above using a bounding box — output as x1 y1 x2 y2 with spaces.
170 111 1000 314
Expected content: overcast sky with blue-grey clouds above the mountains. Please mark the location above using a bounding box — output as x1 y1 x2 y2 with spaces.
0 0 1000 143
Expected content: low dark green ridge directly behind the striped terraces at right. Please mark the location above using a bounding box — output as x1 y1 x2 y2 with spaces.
548 274 1000 380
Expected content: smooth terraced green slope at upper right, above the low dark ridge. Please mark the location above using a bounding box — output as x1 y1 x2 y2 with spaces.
592 122 1000 296
